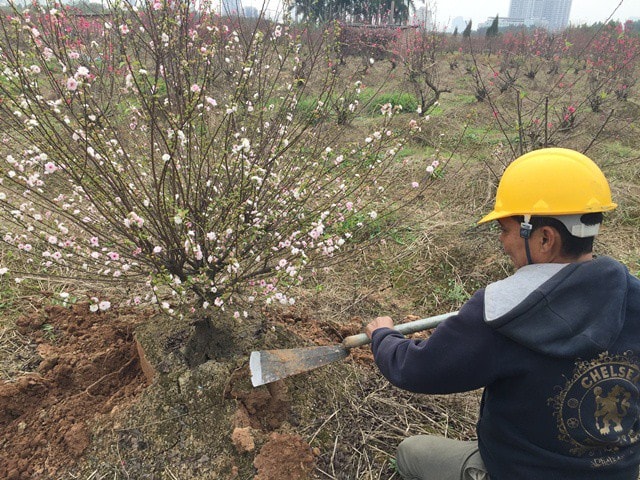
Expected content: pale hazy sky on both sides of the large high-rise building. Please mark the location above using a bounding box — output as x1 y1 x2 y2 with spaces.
428 0 640 28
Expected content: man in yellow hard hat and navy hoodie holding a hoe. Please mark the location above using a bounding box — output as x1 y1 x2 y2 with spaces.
366 148 640 480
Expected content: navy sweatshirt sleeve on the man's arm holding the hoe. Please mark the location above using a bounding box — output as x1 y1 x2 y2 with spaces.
371 290 505 394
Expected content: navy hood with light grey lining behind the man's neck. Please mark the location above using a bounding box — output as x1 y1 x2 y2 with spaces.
484 257 629 358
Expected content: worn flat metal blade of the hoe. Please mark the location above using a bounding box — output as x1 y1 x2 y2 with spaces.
249 345 349 387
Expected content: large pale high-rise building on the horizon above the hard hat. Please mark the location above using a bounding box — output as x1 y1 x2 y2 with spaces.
509 0 572 31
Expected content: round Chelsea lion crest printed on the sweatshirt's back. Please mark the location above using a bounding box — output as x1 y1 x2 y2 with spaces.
549 352 640 460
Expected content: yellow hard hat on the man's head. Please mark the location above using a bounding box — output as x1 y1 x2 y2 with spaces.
478 148 618 224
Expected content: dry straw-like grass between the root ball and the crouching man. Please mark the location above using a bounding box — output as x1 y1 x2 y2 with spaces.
301 365 480 480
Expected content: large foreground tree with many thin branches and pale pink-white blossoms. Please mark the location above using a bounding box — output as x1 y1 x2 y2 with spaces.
0 0 429 317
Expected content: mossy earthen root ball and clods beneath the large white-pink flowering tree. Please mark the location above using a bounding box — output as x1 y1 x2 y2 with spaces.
38 306 318 480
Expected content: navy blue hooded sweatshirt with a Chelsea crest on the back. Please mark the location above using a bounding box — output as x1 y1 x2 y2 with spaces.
372 257 640 480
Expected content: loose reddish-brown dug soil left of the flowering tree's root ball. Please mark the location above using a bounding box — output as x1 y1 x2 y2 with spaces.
0 305 146 479
